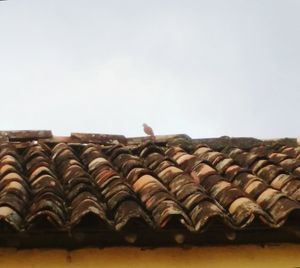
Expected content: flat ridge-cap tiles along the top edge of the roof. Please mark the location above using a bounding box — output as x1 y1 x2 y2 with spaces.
0 130 300 149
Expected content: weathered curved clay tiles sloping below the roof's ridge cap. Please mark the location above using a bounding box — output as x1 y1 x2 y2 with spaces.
0 139 300 232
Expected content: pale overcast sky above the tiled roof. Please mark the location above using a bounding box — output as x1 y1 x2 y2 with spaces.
0 0 300 138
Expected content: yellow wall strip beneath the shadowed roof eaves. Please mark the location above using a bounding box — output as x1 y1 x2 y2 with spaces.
0 244 300 268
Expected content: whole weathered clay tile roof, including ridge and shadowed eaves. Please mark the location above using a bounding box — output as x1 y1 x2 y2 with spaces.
0 131 300 247
